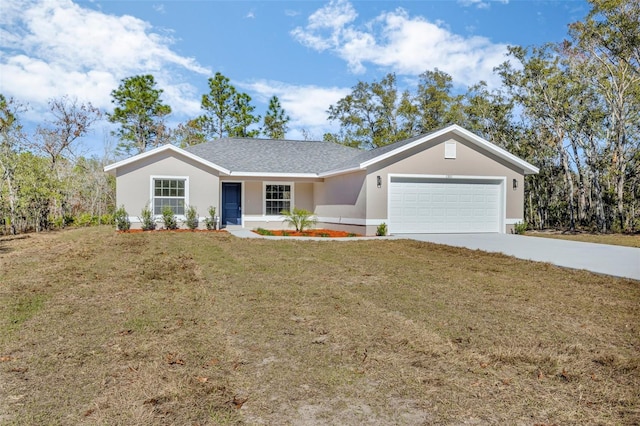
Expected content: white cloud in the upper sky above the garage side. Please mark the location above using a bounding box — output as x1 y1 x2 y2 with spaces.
291 0 507 85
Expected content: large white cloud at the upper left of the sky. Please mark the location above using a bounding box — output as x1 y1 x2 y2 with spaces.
0 0 210 114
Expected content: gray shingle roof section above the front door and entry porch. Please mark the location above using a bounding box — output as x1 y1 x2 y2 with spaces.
185 138 364 173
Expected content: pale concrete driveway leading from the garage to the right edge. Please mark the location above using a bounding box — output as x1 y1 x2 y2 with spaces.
393 234 640 280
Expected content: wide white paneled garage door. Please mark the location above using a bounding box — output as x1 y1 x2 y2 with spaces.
389 177 502 234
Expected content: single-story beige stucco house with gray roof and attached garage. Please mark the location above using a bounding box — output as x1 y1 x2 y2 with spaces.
105 125 538 235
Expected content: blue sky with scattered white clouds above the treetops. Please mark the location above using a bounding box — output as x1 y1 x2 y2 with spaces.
0 0 590 152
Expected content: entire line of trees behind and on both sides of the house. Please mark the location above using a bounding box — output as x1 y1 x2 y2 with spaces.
0 0 640 233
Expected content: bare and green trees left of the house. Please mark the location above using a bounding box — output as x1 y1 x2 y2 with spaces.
0 94 115 234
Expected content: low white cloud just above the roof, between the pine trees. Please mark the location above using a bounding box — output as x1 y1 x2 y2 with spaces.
237 80 351 139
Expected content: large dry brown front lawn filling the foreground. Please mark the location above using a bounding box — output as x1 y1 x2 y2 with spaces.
0 228 640 425
